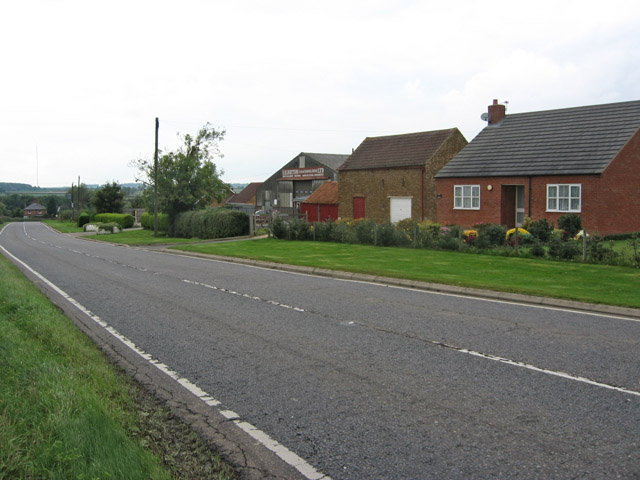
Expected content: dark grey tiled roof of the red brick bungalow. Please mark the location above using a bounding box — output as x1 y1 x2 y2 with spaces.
436 101 640 178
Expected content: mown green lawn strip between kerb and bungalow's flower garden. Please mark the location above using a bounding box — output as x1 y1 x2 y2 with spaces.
171 238 640 308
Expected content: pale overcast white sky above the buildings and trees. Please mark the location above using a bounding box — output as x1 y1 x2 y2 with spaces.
0 0 640 187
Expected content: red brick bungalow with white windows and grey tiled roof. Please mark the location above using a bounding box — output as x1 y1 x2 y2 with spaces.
436 100 640 235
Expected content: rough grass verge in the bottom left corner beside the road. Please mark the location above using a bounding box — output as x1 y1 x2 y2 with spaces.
0 256 238 480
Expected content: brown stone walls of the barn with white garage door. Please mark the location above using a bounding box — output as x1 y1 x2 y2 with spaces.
338 130 467 223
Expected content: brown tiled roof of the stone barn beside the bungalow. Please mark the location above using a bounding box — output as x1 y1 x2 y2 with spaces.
340 128 456 170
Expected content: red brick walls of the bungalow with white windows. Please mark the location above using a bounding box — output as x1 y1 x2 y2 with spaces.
436 133 640 235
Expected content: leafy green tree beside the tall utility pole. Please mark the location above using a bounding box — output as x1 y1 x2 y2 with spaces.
132 123 229 224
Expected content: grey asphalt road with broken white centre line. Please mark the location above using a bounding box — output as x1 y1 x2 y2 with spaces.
0 223 640 479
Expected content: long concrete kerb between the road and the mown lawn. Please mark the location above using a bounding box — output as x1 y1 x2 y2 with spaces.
161 248 640 319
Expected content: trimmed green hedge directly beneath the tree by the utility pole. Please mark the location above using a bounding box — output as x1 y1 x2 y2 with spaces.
170 208 249 239
